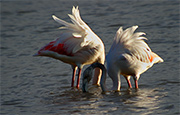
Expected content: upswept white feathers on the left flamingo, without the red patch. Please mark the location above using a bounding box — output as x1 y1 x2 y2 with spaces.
52 6 94 53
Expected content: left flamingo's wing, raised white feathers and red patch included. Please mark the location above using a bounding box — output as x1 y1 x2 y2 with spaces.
38 7 97 56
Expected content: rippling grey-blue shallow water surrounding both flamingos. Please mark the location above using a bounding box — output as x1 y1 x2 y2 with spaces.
0 0 180 115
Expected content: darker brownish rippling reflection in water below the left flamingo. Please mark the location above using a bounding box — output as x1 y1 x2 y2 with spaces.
42 88 103 114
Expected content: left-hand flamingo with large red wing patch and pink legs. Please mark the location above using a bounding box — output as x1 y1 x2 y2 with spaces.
35 6 105 88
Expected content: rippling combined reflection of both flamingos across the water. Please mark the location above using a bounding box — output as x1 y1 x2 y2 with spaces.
41 87 167 114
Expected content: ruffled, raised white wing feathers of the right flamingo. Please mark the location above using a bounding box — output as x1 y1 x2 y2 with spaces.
112 26 152 63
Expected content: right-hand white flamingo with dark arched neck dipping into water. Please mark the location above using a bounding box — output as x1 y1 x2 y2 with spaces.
82 26 163 92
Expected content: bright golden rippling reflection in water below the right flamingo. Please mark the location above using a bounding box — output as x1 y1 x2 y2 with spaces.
123 89 166 114
